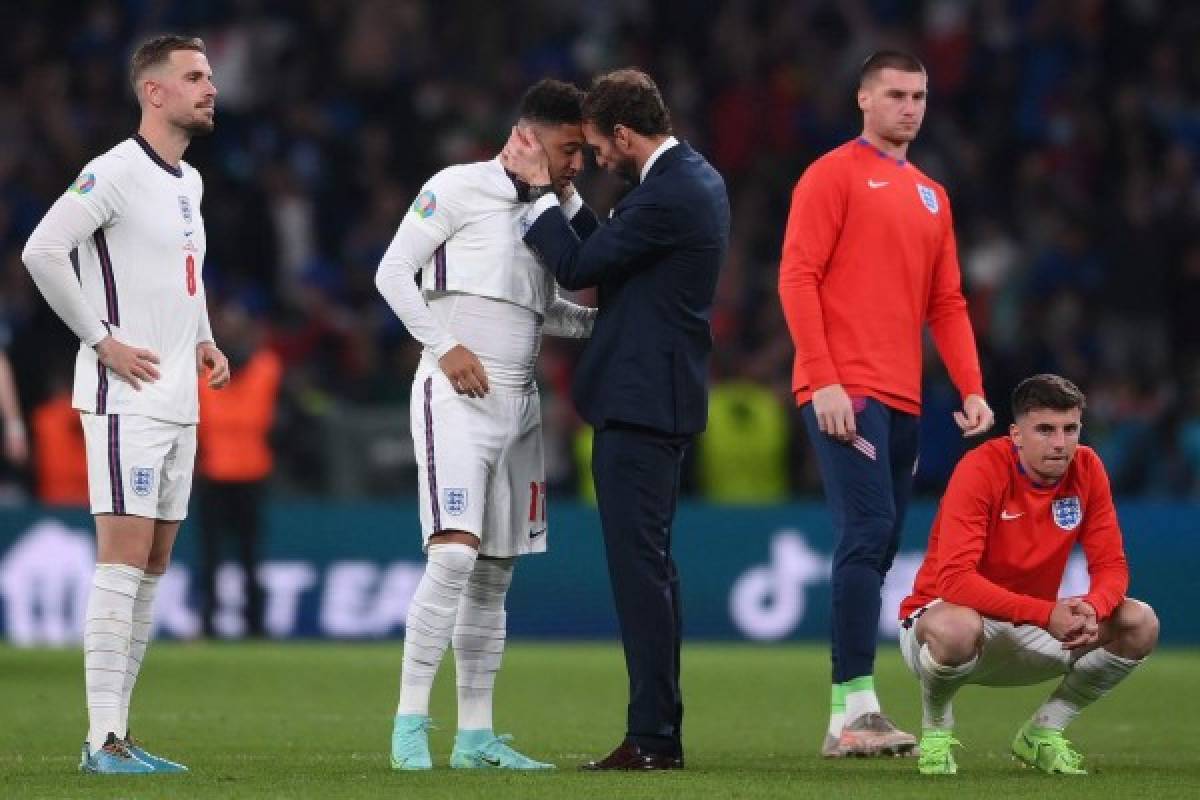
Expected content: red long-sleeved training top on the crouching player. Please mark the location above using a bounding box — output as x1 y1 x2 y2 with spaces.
900 437 1129 627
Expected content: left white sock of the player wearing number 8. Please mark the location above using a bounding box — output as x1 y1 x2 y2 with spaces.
83 564 142 753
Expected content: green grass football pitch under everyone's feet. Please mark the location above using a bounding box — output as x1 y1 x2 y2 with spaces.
0 643 1200 800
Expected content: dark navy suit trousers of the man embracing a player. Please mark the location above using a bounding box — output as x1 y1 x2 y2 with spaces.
592 423 691 754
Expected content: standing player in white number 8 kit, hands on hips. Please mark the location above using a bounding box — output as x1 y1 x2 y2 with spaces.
23 36 229 774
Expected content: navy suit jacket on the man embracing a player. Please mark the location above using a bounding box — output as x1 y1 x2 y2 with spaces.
524 143 730 434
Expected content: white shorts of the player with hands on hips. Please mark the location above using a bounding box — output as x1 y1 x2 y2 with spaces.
79 411 196 522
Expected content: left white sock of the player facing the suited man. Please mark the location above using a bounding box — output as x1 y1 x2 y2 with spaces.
396 543 478 714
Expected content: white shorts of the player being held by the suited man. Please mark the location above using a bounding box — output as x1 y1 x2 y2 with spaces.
409 367 546 558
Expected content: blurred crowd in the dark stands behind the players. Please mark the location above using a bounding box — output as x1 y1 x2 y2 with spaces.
0 0 1200 500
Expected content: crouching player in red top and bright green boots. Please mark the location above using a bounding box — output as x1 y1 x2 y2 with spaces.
900 375 1158 775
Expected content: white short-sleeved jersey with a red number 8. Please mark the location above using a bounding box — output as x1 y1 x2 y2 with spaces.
57 137 211 423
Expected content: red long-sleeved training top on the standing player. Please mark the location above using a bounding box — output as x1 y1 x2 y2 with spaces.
779 138 983 414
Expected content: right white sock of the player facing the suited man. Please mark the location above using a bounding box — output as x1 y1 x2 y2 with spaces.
454 559 516 730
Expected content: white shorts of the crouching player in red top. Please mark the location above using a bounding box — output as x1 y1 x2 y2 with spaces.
900 600 1078 686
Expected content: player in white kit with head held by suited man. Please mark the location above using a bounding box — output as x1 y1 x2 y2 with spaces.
376 80 595 770
